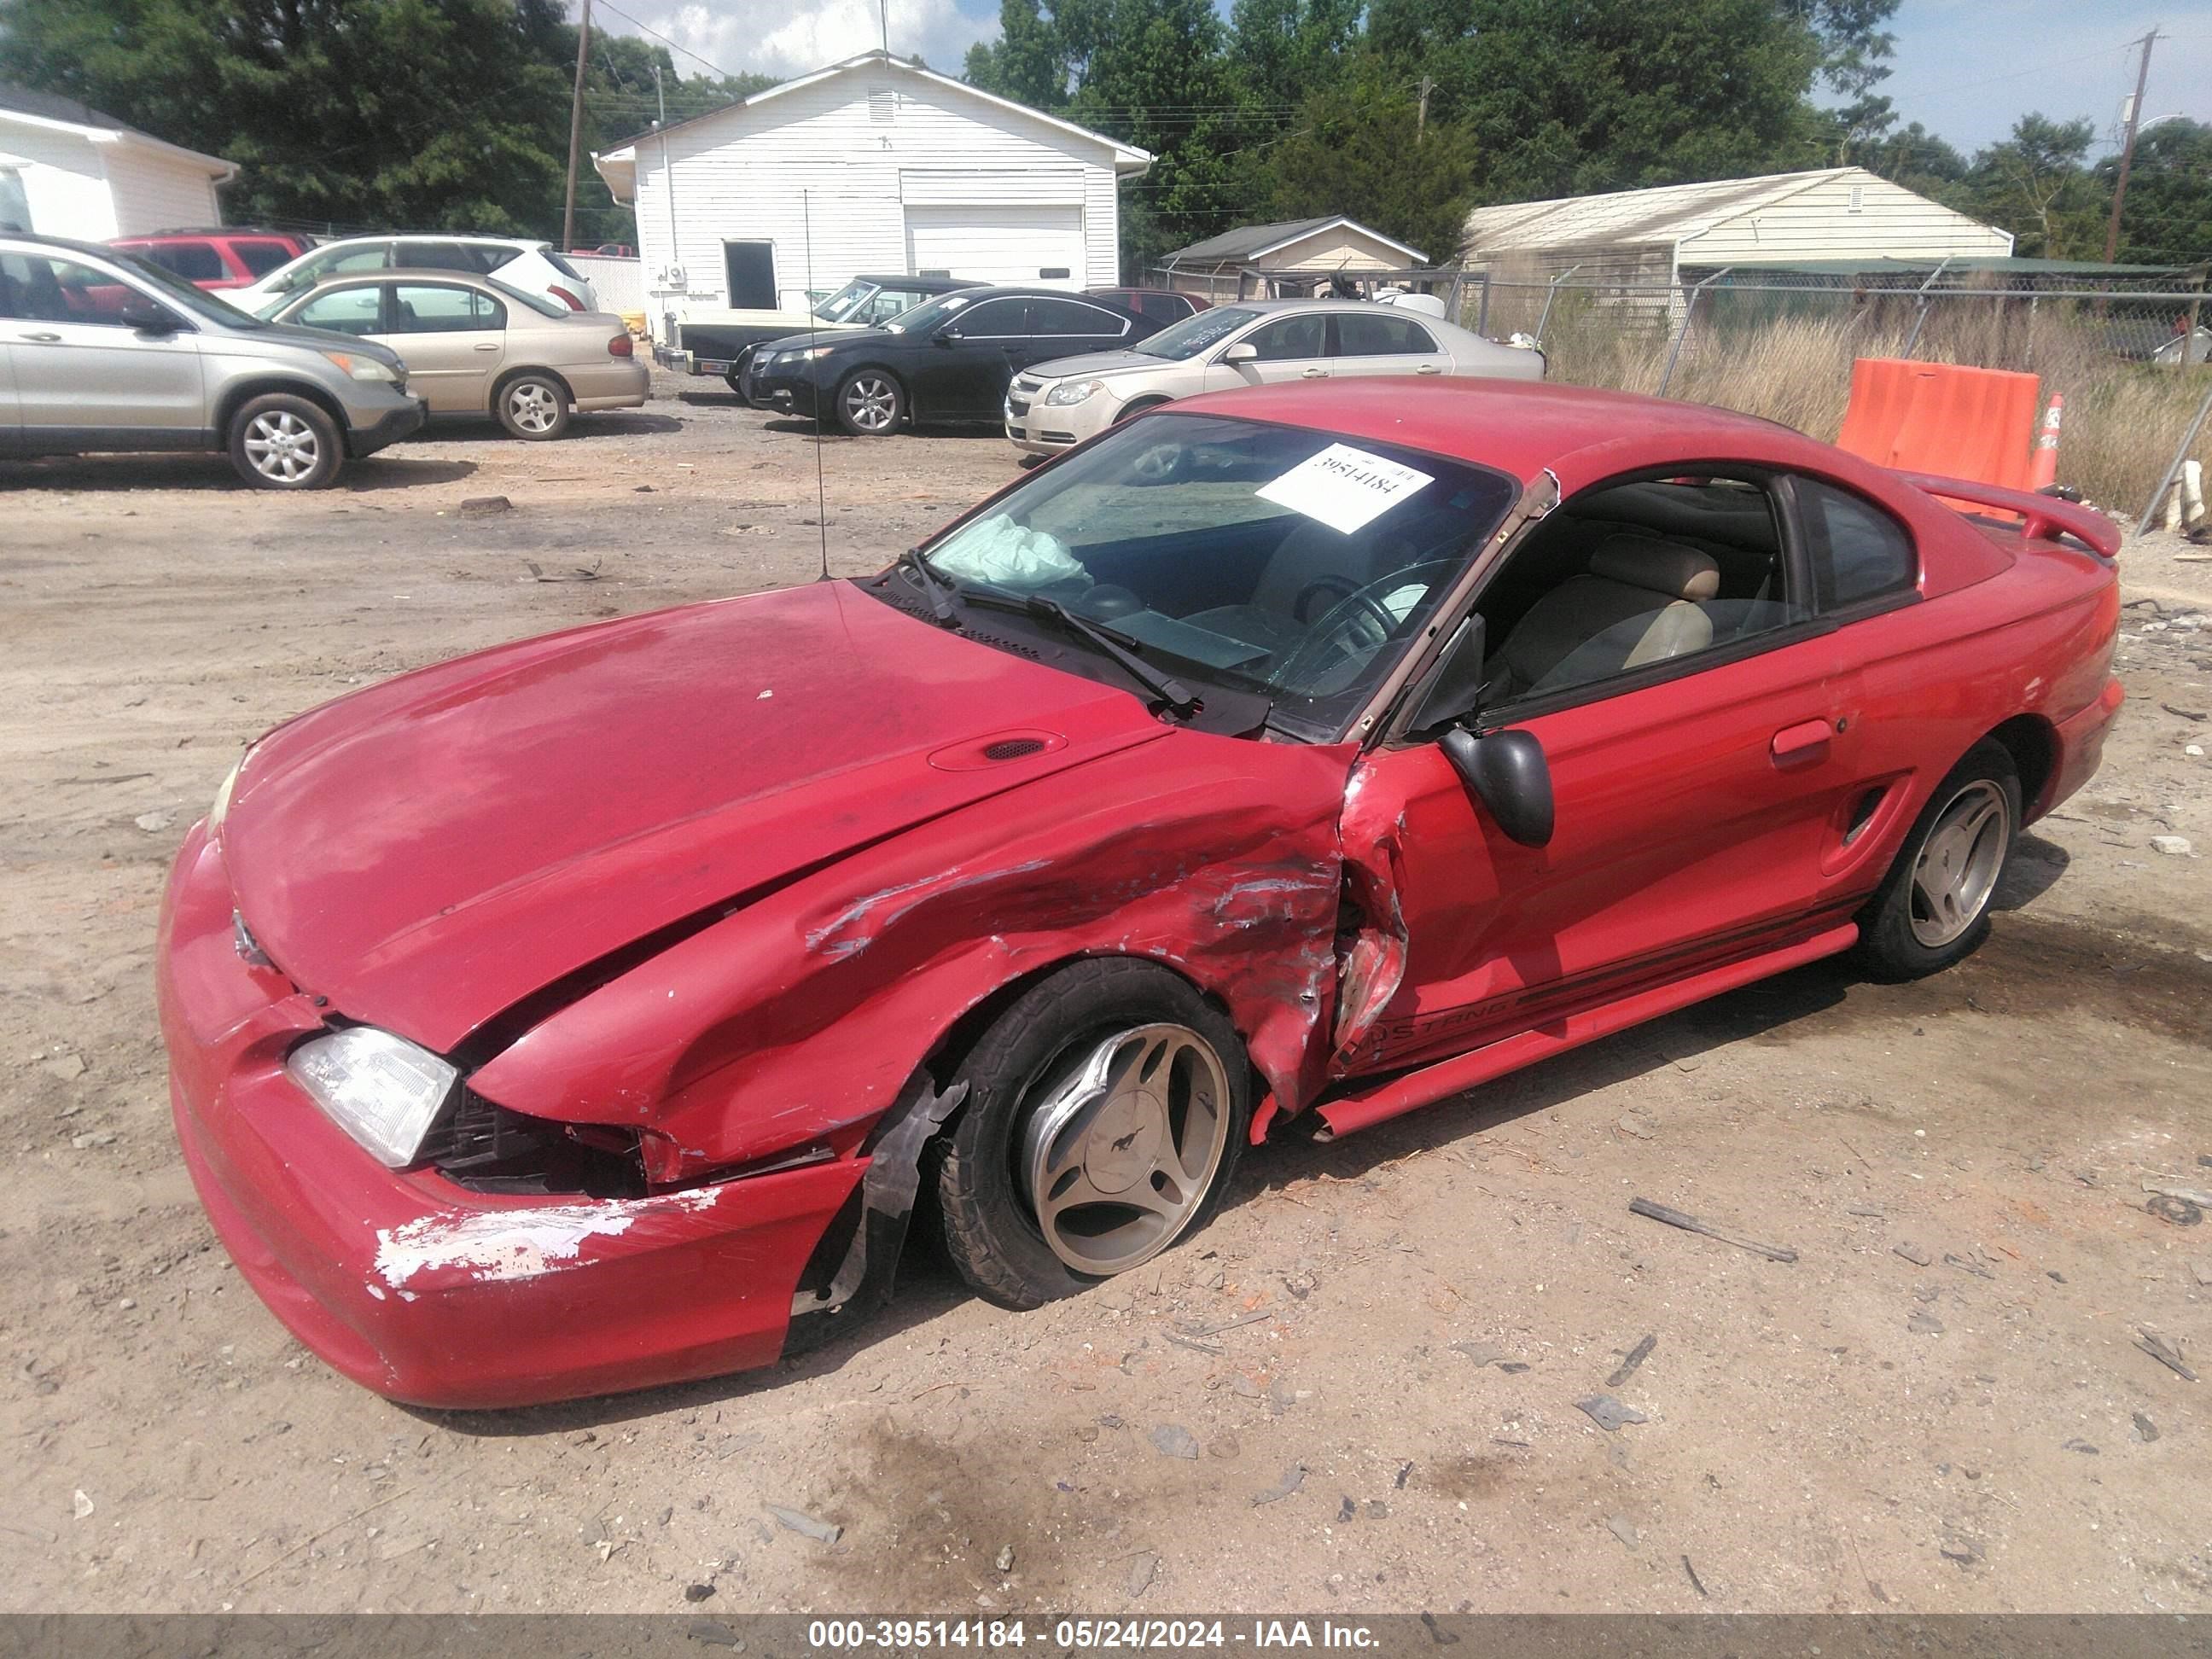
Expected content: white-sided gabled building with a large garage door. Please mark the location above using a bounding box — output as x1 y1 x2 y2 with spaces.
591 51 1152 345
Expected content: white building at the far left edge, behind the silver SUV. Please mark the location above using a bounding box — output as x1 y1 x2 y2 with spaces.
0 84 239 242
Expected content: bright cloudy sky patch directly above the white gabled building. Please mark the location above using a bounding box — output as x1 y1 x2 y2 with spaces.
602 0 998 78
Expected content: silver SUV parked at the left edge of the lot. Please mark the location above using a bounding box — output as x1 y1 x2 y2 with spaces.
0 232 425 489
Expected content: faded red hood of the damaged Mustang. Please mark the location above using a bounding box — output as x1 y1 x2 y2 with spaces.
221 582 1166 1049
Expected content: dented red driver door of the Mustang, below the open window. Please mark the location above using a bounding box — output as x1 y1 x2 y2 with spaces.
1338 486 1865 1073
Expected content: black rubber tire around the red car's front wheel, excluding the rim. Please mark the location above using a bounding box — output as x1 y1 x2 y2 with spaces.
938 958 1252 1307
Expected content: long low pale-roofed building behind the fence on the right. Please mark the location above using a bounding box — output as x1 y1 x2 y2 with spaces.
1460 168 2013 285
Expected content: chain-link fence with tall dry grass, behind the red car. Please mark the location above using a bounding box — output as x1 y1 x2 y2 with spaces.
1456 268 2212 513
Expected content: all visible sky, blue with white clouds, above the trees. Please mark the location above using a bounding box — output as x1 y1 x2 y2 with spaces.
595 0 2212 154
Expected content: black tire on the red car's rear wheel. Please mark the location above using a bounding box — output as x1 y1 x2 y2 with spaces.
1856 739 2019 982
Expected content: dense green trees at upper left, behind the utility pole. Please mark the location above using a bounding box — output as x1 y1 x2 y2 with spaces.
0 0 767 242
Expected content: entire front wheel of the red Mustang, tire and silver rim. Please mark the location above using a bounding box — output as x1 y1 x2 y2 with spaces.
938 960 1252 1307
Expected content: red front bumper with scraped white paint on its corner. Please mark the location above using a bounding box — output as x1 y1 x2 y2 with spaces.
157 825 864 1409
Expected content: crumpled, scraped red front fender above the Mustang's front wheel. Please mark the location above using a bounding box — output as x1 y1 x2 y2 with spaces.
471 730 1353 1184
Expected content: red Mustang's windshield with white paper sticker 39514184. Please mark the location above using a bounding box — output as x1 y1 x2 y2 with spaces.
927 414 1517 741
